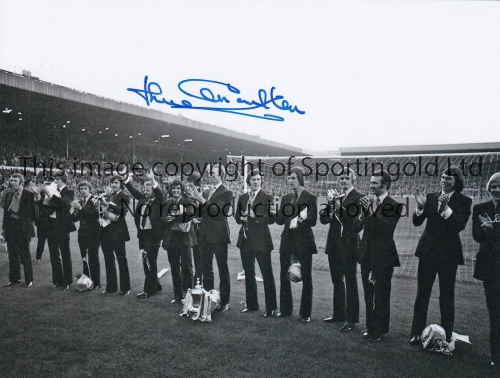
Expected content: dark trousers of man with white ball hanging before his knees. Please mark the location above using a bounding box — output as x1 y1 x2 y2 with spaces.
278 253 312 318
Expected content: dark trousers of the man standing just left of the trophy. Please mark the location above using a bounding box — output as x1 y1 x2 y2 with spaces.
167 231 193 299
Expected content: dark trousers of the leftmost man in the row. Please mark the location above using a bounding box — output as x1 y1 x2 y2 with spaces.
5 228 33 282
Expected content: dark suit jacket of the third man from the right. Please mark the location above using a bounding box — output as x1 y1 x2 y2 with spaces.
353 195 401 273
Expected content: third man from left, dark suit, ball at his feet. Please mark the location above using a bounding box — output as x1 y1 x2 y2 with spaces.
71 181 101 290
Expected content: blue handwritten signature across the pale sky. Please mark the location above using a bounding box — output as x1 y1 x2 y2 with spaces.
127 76 305 122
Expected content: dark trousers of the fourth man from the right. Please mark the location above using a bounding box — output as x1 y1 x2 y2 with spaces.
328 254 359 324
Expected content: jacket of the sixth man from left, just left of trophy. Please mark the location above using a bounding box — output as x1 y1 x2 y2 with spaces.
162 197 198 249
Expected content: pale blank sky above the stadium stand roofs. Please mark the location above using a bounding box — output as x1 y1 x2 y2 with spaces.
0 0 500 151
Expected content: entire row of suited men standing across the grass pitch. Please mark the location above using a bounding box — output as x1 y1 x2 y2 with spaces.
3 165 500 363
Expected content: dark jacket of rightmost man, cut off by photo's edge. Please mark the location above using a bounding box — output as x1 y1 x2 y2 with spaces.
472 200 500 281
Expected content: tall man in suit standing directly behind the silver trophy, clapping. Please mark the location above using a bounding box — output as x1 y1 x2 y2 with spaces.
187 164 233 311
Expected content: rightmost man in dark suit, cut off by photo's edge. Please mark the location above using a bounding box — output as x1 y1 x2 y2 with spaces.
472 172 500 369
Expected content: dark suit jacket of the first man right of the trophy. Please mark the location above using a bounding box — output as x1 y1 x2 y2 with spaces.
235 189 275 252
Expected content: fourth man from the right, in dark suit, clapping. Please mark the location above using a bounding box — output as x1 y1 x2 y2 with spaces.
320 168 363 332
